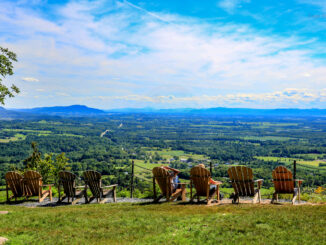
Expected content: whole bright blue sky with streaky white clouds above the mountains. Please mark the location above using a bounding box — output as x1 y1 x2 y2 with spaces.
0 0 326 109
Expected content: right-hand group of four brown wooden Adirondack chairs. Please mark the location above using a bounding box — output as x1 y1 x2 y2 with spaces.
152 166 303 205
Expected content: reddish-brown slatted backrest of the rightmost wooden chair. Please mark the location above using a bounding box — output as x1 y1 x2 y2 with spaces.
272 166 294 194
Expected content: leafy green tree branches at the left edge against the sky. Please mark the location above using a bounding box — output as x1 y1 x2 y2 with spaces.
0 47 19 105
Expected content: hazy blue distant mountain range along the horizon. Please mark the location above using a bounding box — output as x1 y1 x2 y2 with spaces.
0 105 326 119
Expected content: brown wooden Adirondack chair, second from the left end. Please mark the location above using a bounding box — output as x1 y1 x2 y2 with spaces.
24 170 52 202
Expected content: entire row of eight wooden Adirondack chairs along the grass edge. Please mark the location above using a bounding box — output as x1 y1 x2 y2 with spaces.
5 166 302 205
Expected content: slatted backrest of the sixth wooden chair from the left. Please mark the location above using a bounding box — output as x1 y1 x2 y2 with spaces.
190 166 211 196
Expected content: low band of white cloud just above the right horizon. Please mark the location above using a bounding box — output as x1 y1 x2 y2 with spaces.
95 88 326 108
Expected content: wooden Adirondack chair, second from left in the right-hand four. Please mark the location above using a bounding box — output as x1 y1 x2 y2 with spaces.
190 166 222 205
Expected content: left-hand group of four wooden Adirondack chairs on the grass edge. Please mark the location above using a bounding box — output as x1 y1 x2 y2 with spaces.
5 170 117 204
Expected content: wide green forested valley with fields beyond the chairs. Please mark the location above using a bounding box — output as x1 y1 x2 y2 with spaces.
0 113 326 195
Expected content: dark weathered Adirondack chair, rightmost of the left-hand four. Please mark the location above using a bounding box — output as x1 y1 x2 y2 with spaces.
83 170 118 203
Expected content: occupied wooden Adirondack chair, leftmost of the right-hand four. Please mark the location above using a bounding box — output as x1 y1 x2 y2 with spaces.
152 167 186 202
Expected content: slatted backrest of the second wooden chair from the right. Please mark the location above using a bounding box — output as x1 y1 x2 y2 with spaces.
228 166 255 196
